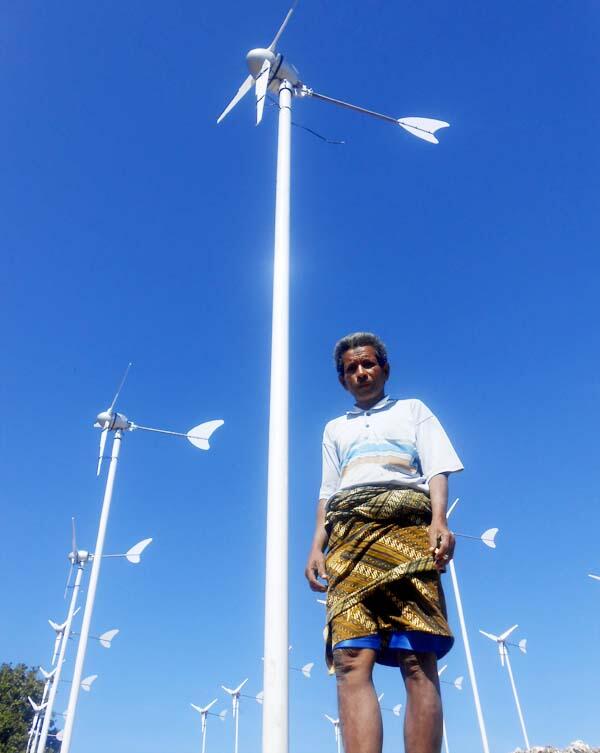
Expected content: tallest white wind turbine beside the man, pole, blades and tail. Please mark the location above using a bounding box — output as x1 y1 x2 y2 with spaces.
217 5 448 753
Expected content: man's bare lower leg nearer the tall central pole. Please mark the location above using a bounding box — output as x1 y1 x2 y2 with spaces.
333 648 383 753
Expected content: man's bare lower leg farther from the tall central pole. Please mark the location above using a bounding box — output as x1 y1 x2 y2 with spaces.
398 651 442 753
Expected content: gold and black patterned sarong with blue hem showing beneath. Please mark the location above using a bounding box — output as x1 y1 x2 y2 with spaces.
325 486 454 671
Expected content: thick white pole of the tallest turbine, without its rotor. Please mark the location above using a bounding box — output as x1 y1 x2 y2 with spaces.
262 81 293 753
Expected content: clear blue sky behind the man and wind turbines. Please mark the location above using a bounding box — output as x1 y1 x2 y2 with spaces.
0 0 600 753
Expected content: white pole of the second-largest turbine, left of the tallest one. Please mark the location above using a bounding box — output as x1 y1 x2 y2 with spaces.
60 429 122 753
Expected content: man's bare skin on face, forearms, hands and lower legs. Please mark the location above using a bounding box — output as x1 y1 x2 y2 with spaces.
305 345 454 753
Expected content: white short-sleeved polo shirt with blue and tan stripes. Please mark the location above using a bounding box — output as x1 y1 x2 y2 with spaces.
319 396 463 499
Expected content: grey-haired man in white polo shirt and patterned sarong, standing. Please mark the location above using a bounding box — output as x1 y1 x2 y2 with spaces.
305 332 463 753
